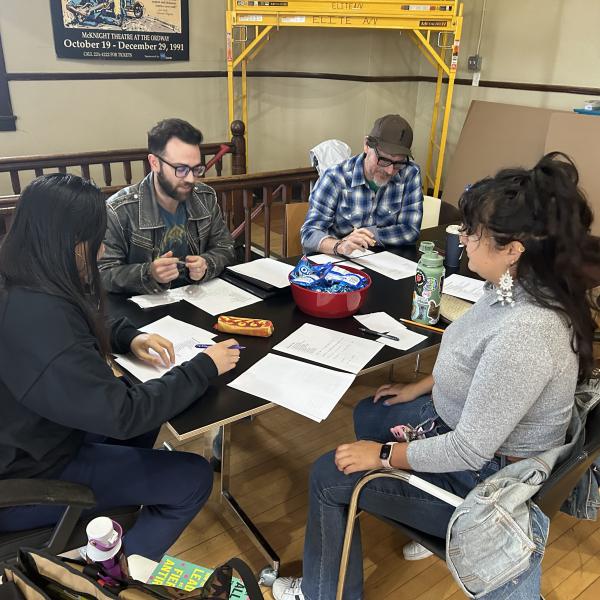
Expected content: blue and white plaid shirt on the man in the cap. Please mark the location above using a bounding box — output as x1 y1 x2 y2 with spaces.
300 154 423 252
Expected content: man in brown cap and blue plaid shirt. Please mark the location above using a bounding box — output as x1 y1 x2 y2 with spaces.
300 115 423 256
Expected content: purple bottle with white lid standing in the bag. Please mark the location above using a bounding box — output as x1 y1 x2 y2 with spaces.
85 517 127 580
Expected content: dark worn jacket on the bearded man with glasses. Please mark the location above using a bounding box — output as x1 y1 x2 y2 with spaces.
98 173 234 294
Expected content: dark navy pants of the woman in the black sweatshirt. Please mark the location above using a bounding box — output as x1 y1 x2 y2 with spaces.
0 431 213 561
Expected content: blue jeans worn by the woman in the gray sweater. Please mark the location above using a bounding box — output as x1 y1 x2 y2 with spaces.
302 395 541 600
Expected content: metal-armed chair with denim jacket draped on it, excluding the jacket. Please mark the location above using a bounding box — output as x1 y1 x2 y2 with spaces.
337 404 600 600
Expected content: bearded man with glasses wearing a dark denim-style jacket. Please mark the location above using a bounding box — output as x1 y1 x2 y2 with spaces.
99 119 234 294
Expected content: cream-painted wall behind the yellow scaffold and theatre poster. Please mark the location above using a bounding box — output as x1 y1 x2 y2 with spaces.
0 0 600 193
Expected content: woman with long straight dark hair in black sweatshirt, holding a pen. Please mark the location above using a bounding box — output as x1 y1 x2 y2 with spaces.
0 174 239 560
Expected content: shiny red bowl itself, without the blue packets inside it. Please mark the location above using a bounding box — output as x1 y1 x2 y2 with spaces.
290 266 372 319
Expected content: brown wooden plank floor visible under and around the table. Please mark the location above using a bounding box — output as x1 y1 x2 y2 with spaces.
158 354 600 600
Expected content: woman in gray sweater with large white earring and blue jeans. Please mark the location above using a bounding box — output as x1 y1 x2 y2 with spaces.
273 153 600 600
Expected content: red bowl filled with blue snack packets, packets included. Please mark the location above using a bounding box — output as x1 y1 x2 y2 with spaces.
289 256 372 319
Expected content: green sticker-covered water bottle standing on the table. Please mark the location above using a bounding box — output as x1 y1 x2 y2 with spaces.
410 242 445 325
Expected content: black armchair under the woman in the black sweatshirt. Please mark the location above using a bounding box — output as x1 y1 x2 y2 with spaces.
0 479 140 562
